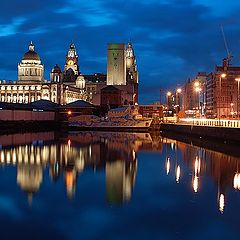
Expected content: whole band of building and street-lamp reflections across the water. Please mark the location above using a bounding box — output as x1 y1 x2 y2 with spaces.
0 132 240 213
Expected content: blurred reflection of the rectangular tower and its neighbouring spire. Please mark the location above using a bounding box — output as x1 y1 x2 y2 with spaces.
106 160 137 204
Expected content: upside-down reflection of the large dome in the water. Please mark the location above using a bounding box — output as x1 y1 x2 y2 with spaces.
17 164 43 203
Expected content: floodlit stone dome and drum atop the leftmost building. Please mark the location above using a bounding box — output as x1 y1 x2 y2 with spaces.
18 42 44 83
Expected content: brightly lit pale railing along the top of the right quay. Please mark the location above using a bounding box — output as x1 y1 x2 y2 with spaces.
178 118 240 128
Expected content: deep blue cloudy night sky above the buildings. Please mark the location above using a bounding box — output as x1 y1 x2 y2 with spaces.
0 0 240 103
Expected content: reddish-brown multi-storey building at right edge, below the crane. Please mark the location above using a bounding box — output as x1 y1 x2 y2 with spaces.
206 59 240 118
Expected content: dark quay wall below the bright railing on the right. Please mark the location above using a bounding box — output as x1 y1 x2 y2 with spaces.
160 123 240 141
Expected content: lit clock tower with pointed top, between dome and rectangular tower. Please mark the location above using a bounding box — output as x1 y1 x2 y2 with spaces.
64 42 80 82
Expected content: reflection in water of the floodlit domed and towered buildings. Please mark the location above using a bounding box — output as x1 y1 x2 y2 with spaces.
0 132 162 205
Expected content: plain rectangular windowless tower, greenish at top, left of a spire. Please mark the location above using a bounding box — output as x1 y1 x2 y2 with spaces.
107 43 126 85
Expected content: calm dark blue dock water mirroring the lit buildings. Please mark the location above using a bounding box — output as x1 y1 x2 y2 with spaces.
0 132 240 240
